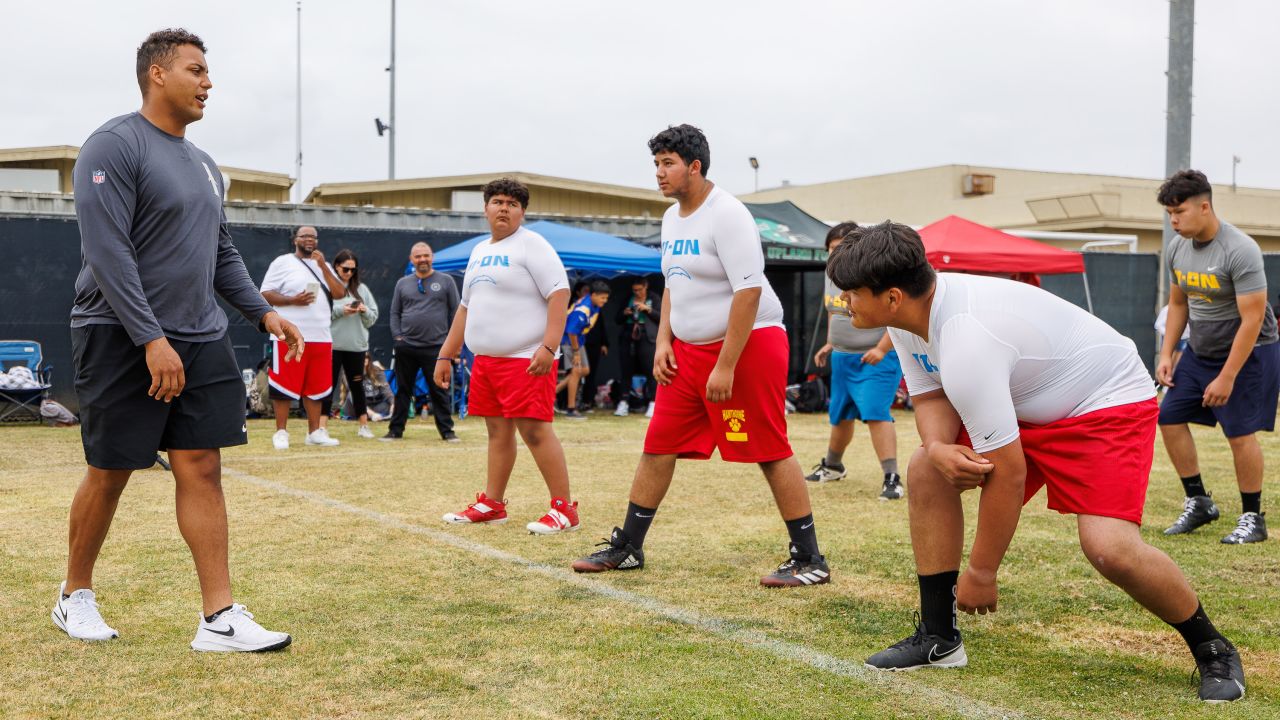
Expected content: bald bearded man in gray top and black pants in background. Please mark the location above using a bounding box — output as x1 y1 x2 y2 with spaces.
384 242 458 442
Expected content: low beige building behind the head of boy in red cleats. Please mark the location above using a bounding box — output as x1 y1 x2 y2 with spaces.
305 173 672 218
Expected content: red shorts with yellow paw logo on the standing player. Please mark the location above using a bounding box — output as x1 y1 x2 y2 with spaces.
644 328 792 462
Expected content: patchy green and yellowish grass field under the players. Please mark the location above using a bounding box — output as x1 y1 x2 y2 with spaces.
0 414 1280 720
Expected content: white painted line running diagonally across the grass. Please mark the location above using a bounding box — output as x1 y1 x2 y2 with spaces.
223 468 1028 719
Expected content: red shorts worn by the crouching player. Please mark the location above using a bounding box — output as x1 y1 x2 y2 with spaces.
956 398 1160 525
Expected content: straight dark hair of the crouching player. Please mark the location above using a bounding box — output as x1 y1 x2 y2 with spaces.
827 220 936 297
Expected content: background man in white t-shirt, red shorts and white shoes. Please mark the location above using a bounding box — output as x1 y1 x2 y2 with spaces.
260 225 347 450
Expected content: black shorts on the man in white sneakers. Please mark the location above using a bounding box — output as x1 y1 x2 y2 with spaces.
72 325 248 470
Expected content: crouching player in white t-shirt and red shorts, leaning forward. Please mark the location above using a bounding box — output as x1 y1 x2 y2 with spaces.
827 222 1244 702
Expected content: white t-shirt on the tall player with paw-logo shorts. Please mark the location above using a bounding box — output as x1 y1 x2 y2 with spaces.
662 186 782 345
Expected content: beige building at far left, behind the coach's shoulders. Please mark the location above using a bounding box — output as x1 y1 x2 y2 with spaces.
0 145 293 202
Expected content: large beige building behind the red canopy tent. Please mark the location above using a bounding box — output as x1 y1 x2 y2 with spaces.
741 165 1280 252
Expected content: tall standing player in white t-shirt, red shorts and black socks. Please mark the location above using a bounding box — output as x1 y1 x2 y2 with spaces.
573 124 831 587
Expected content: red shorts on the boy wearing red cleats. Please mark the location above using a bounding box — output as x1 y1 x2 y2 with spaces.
467 355 557 423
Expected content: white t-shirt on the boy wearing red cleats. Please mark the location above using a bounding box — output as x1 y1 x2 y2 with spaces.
461 228 568 357
